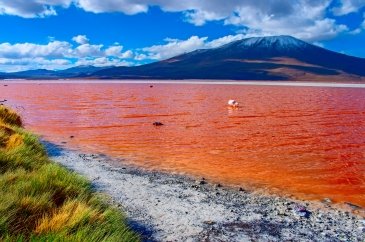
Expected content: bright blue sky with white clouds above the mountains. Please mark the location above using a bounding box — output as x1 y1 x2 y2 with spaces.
0 0 365 71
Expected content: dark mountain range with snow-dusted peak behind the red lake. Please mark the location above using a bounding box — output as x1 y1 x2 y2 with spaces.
0 36 365 80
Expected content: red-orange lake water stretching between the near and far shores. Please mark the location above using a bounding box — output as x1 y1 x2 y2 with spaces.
0 83 365 206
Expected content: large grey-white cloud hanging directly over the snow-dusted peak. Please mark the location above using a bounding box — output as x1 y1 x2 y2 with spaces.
225 0 347 42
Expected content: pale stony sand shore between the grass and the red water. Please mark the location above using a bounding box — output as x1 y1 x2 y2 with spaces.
46 143 365 241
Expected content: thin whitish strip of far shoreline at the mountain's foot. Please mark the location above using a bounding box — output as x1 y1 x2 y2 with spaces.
0 79 365 88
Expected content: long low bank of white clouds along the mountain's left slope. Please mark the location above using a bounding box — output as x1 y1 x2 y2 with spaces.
0 34 264 72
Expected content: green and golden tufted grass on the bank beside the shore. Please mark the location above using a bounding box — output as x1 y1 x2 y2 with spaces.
0 106 140 242
